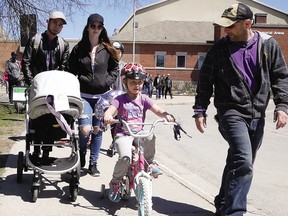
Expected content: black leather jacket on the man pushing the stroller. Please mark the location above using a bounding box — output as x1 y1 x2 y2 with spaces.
22 32 69 84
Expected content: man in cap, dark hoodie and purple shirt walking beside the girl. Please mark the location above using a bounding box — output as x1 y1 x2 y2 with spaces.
193 3 288 216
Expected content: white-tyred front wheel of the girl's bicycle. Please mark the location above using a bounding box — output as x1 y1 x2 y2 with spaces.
136 176 152 216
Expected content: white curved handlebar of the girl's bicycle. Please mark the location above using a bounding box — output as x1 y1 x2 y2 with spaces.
114 118 177 138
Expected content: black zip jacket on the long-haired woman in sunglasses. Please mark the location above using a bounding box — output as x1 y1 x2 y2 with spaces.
68 42 119 95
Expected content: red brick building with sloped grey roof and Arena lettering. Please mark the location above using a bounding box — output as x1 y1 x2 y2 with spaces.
111 0 288 81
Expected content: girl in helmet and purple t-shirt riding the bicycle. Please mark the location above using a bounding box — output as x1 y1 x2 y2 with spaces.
104 63 175 202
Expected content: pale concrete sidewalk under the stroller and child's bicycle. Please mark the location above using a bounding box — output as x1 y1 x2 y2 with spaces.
0 130 214 216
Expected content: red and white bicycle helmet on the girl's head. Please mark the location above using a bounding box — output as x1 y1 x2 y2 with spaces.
121 62 146 80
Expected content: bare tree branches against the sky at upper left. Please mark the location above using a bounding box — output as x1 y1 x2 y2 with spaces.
0 0 155 41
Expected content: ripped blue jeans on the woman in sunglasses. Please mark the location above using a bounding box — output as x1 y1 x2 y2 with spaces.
79 98 102 164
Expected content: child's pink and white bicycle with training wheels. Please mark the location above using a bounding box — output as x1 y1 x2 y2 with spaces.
101 119 177 216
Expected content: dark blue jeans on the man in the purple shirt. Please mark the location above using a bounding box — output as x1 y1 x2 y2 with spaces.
214 116 265 216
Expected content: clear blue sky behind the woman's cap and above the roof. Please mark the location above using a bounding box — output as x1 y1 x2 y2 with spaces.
60 0 288 38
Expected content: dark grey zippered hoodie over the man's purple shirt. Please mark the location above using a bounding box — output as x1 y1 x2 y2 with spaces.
193 32 288 118
